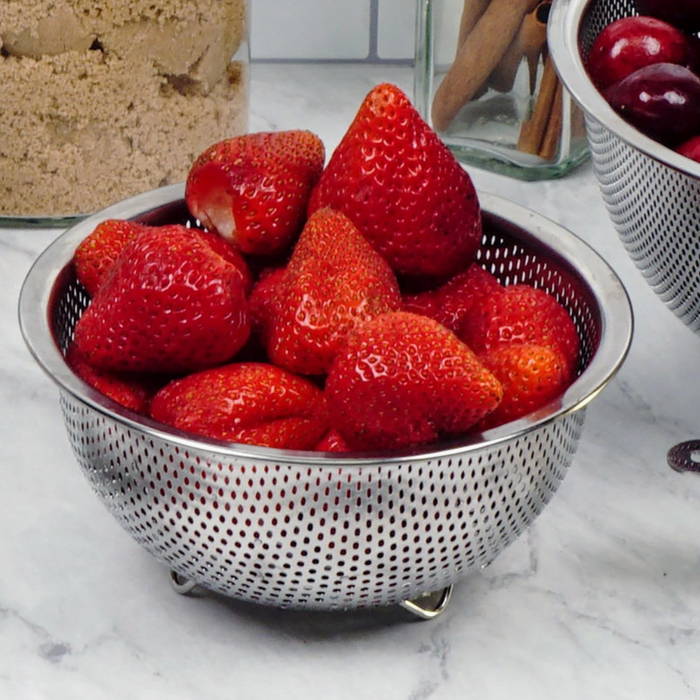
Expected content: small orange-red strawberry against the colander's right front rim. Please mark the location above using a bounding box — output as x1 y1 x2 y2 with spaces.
479 343 569 430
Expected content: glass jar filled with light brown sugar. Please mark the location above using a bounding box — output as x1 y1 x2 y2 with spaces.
0 0 250 226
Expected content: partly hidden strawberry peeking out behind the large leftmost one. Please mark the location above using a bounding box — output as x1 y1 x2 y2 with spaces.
73 219 145 296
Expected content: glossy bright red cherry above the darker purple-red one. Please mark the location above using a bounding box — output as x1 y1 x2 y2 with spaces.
588 15 700 90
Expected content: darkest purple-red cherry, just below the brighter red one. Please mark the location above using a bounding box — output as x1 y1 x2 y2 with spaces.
603 63 700 148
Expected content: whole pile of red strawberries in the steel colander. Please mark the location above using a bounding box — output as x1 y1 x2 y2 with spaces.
66 84 579 452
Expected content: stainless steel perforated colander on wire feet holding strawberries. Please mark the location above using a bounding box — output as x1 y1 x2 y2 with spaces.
19 186 632 616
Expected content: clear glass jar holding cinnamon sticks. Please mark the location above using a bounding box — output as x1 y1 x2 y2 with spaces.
414 0 588 180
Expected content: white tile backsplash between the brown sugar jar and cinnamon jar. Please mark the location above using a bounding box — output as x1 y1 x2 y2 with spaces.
250 0 416 61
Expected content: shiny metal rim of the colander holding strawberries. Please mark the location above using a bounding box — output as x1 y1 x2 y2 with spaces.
18 183 634 467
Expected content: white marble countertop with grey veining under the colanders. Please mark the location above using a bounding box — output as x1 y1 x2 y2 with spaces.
0 64 700 700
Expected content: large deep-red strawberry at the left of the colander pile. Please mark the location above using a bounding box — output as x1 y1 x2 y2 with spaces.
74 225 250 373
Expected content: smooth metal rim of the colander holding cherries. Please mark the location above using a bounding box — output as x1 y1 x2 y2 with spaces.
547 0 700 179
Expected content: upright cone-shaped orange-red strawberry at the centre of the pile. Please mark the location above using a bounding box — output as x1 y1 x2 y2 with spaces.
262 209 401 374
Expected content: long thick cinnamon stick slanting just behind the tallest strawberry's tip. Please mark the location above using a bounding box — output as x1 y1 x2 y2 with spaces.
431 0 539 131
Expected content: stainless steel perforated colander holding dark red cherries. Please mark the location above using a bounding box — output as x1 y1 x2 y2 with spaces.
548 0 700 333
